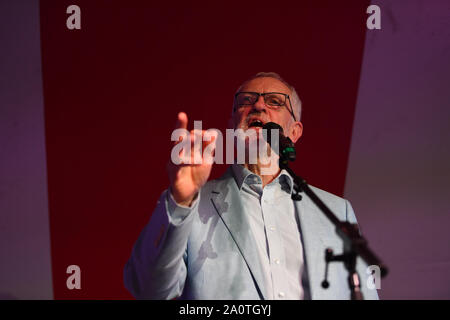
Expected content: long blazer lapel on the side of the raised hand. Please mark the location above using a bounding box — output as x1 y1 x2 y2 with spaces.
211 170 266 299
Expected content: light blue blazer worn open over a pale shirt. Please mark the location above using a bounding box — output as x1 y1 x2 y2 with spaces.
124 167 378 300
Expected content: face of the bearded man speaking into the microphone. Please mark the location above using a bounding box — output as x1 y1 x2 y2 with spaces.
231 77 302 142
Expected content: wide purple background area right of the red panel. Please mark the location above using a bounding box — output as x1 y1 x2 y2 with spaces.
345 0 450 299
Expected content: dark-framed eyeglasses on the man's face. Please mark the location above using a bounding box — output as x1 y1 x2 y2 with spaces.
234 91 297 121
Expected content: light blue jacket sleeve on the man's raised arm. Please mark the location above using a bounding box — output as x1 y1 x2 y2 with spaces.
124 190 200 300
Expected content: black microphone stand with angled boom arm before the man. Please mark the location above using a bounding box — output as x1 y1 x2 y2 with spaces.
279 156 387 300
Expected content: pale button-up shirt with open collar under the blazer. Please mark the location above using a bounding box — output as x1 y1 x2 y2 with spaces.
232 164 308 300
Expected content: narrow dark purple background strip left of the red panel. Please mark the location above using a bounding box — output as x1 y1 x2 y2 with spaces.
0 1 53 299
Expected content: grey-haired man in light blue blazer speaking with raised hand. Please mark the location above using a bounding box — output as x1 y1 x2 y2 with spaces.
124 73 378 300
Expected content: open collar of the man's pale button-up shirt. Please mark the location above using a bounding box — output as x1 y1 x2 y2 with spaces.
231 164 294 194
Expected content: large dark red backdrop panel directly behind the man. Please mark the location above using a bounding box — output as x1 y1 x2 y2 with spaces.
40 0 369 299
